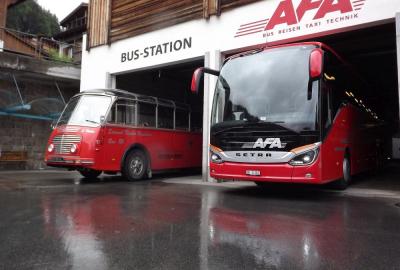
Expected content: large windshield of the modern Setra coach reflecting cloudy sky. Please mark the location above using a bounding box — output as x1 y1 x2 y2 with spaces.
211 45 318 132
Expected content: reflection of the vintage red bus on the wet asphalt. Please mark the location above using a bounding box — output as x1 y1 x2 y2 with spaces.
40 186 200 269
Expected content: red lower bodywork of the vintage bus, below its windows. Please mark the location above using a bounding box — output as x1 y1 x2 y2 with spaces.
46 125 202 172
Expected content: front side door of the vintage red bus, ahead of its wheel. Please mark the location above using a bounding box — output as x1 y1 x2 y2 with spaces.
103 99 136 170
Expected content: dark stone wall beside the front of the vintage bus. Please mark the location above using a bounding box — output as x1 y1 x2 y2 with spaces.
0 70 79 170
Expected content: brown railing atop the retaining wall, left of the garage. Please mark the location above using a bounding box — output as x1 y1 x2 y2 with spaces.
0 27 82 64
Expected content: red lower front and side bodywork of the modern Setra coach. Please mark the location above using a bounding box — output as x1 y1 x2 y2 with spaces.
210 105 379 184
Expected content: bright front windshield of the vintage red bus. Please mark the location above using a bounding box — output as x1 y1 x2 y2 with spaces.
57 95 111 127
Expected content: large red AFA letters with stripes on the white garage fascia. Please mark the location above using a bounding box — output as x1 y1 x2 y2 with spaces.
235 0 367 37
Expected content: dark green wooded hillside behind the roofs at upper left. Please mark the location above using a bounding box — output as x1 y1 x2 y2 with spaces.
7 0 60 37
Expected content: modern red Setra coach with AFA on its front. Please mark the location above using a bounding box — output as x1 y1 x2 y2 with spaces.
192 42 382 189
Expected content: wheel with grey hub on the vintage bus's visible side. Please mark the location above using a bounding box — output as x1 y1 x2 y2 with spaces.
123 150 148 181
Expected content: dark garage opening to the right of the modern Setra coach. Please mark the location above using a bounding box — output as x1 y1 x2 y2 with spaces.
314 22 400 191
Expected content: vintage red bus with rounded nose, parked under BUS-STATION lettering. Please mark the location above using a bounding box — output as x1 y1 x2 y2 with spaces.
45 90 202 180
